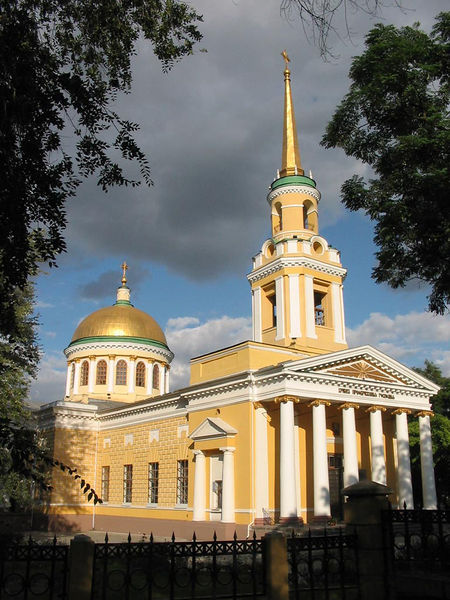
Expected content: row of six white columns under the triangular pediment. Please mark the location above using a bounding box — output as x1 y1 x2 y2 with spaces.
270 397 437 522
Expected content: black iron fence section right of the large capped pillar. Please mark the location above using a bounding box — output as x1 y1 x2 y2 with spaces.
383 508 450 573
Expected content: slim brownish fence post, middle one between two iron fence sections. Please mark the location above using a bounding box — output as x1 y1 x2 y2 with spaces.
264 531 289 600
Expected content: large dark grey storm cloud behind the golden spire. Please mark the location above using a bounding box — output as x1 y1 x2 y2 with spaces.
62 0 442 284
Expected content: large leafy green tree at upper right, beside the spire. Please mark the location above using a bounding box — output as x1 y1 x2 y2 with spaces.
322 13 450 313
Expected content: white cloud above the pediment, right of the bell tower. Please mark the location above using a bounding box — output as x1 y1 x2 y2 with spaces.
347 312 450 374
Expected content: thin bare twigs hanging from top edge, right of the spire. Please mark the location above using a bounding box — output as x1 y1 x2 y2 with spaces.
280 0 401 58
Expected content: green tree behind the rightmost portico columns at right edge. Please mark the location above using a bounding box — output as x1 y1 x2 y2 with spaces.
409 360 450 508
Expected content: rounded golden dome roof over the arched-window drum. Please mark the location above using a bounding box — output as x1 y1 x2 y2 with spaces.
70 302 167 347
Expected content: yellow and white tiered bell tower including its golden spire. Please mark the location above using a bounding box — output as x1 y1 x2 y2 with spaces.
248 51 347 354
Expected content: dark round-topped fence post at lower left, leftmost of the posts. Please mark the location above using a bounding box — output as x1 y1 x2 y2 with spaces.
69 534 95 600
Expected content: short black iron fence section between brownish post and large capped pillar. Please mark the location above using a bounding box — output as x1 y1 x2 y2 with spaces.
287 529 360 600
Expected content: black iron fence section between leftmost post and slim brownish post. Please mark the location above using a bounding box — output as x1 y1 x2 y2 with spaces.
92 534 265 600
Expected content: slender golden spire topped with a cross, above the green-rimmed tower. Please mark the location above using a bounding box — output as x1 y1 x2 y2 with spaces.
280 50 304 177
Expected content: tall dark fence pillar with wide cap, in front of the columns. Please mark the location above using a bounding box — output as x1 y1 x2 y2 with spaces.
342 480 392 600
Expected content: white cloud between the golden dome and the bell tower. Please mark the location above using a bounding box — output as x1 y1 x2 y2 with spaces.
165 315 252 390
